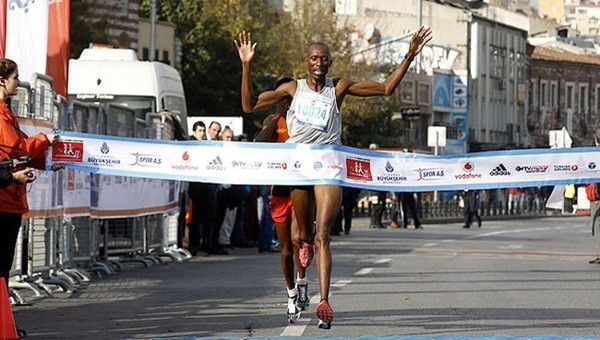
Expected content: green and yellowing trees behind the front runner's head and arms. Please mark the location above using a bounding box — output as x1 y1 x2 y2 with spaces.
140 0 408 146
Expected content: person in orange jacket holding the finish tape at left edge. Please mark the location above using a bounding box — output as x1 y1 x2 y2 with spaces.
0 59 58 287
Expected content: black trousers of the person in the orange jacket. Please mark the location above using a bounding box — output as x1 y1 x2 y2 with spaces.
0 213 23 288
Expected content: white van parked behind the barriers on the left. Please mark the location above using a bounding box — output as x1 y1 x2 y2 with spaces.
68 48 187 133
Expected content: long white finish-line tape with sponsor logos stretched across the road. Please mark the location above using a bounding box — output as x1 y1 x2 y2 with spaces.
57 132 600 192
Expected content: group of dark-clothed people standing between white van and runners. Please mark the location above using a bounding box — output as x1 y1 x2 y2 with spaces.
187 120 279 256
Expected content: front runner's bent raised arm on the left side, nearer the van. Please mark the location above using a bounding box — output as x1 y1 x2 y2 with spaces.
234 31 296 113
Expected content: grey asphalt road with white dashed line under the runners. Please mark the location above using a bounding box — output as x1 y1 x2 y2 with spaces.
13 217 600 339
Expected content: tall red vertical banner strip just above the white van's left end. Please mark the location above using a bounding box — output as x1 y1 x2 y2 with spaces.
46 0 71 98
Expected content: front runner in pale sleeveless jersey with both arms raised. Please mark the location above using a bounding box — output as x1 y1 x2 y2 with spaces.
235 27 432 329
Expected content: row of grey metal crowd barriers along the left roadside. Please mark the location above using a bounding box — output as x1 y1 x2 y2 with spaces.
10 74 191 302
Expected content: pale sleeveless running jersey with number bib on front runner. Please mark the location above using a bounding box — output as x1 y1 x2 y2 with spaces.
286 78 342 144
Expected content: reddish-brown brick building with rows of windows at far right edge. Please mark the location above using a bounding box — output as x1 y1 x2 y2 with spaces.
527 45 600 147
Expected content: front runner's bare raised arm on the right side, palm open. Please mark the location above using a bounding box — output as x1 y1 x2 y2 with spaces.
338 27 432 98
